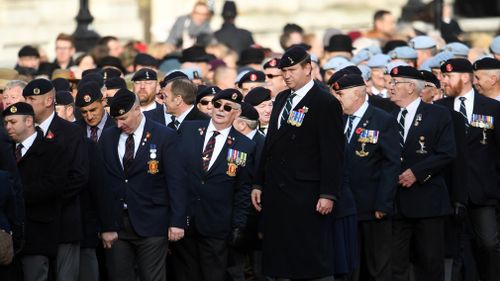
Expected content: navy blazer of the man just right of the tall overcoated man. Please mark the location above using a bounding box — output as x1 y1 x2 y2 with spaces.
346 105 401 220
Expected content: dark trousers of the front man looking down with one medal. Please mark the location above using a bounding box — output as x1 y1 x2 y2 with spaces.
105 212 168 281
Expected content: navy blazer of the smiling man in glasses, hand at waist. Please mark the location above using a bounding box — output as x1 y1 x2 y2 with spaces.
395 99 456 218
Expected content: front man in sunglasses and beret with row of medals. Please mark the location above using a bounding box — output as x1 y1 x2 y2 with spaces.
173 89 255 281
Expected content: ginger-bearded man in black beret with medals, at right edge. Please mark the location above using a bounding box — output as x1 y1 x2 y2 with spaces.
436 58 500 280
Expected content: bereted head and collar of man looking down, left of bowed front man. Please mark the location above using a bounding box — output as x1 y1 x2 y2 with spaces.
75 82 115 142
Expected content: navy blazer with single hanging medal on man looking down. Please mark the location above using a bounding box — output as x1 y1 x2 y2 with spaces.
99 117 186 237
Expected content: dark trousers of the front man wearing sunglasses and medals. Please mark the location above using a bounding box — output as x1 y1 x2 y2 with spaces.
172 226 228 281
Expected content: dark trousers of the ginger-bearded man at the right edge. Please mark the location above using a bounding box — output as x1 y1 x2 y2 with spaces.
468 203 500 281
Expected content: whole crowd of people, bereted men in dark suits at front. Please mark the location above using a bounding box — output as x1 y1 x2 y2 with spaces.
0 1 500 281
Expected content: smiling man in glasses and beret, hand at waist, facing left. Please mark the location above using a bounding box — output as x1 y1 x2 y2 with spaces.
389 66 456 280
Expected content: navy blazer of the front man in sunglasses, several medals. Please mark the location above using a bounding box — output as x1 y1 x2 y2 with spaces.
181 120 255 239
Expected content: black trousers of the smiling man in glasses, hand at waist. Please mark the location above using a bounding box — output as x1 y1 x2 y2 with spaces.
392 217 444 281
